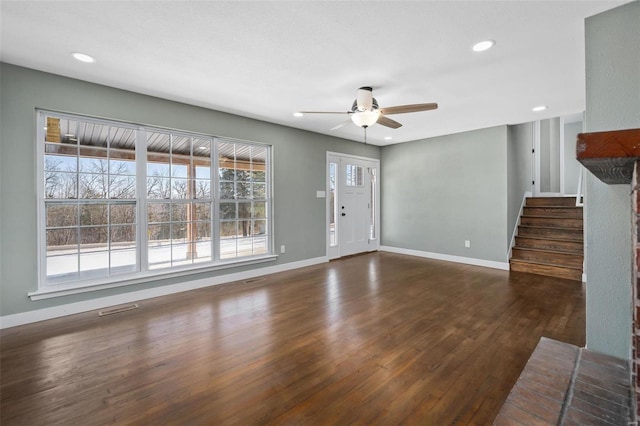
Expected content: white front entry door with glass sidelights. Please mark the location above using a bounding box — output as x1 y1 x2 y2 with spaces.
326 152 380 259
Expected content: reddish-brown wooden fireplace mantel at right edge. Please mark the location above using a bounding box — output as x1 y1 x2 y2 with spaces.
576 129 640 185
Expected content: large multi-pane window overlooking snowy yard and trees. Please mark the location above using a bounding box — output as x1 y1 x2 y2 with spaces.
38 111 272 287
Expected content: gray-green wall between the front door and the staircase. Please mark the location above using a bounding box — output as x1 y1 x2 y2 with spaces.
381 126 507 262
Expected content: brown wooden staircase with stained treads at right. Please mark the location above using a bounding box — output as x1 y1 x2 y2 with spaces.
509 197 584 281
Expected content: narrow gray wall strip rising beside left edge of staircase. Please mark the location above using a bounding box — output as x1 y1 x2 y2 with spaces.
507 123 533 248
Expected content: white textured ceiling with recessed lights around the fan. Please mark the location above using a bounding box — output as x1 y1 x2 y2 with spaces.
0 0 627 145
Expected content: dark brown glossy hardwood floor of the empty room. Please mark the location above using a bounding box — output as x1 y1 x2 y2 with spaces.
0 252 585 426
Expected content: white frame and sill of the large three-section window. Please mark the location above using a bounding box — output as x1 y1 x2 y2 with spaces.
34 109 277 300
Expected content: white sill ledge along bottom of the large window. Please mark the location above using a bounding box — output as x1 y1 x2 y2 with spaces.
27 255 278 300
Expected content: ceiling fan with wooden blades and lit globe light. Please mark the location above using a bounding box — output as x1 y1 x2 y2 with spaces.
300 86 438 130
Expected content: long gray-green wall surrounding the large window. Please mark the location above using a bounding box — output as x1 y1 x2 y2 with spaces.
0 64 380 315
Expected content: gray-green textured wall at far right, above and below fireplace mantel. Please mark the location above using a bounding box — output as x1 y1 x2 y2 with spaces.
585 1 640 358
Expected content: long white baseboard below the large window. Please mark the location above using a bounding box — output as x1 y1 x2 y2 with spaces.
0 256 329 329
